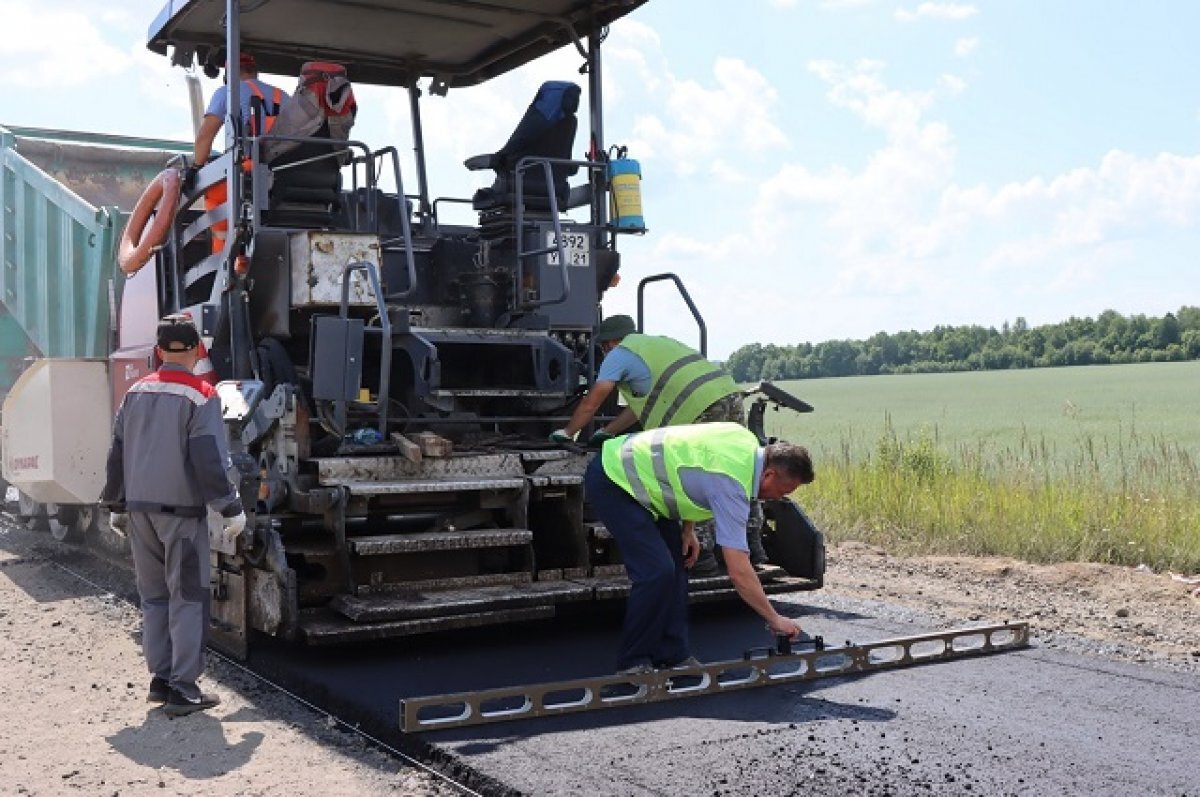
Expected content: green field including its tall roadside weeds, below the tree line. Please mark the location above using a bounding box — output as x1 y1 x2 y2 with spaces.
768 361 1200 573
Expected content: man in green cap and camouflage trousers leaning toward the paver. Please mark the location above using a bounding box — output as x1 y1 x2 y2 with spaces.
550 316 767 576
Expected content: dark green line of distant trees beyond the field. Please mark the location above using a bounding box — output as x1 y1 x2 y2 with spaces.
725 307 1200 382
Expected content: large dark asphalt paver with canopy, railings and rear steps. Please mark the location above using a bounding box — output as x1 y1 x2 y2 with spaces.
6 0 824 654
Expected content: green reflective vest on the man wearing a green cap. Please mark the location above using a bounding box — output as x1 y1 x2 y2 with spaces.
617 334 738 429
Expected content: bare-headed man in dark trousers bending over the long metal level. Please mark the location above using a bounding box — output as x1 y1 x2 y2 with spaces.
583 423 814 675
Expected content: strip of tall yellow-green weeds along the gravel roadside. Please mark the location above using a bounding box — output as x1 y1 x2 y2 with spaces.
802 423 1200 573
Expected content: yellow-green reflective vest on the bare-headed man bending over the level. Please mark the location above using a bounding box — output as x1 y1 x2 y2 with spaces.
600 423 758 521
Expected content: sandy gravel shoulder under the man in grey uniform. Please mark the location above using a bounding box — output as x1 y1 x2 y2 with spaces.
0 517 460 797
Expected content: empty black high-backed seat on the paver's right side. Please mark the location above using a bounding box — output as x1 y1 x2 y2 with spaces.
466 80 580 211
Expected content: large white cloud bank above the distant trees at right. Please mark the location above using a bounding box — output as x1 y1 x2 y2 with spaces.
739 56 1200 341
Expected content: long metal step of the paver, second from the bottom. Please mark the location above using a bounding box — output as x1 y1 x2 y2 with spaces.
329 581 592 623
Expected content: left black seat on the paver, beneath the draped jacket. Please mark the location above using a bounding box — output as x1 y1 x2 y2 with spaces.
265 121 346 228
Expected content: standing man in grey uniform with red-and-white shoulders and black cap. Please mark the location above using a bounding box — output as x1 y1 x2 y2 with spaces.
101 314 246 717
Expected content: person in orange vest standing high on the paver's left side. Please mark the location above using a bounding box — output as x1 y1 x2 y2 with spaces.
193 52 288 252
